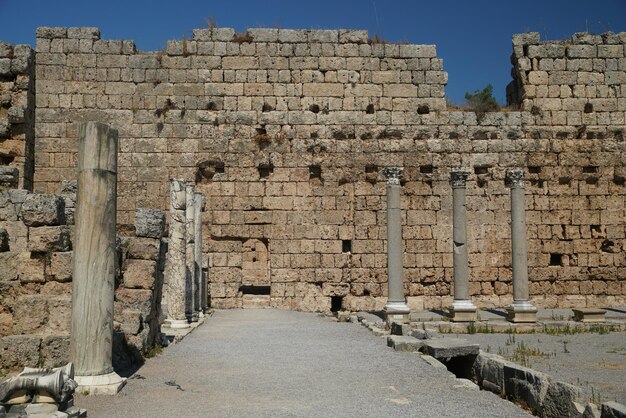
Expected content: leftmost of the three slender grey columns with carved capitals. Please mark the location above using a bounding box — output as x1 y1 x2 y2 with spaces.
382 167 410 322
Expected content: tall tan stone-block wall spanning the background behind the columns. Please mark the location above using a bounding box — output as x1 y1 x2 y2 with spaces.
29 28 626 311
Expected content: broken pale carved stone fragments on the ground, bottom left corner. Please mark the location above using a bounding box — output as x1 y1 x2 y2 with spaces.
0 363 87 418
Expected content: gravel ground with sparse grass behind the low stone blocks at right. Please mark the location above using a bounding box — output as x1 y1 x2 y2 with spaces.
458 332 626 405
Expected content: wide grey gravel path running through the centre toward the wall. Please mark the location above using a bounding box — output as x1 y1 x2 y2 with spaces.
76 309 528 418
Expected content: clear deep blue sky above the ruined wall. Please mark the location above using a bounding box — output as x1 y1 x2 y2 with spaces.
0 0 626 104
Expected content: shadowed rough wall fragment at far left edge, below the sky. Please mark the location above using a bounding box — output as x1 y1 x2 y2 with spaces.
0 41 35 190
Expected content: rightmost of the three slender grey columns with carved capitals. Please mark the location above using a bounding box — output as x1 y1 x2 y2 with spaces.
506 169 537 322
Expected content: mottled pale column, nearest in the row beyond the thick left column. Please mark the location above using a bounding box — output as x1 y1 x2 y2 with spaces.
166 179 189 328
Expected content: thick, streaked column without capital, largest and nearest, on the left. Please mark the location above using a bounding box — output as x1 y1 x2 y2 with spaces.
70 122 126 395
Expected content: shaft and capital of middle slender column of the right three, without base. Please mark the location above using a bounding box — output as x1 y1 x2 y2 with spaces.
452 171 469 300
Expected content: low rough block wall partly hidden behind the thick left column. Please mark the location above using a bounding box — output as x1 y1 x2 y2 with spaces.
0 183 165 369
